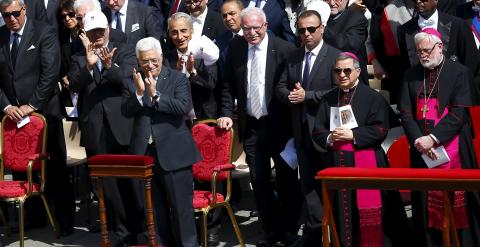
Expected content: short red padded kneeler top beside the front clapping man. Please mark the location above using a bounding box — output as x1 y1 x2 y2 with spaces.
88 154 153 166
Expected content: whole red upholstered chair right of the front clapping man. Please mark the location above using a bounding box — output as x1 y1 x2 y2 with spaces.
192 120 245 247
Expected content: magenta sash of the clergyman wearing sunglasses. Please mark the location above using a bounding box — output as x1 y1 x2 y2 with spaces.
333 142 383 247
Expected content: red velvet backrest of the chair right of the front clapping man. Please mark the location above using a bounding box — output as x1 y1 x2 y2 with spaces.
192 121 233 181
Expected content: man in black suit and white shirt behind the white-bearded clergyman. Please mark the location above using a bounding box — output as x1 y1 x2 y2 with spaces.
398 0 480 102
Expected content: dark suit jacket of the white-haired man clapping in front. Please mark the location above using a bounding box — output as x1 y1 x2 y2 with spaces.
122 66 201 171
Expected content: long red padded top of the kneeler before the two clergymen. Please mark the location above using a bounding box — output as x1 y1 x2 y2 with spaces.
317 167 480 179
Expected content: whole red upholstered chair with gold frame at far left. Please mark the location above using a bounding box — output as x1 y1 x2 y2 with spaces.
0 113 57 247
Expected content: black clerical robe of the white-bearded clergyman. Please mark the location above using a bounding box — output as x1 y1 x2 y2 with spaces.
398 59 480 246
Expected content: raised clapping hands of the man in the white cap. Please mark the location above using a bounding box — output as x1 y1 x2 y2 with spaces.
79 32 117 70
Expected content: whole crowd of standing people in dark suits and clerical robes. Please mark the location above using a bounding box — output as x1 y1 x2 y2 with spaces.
0 0 480 247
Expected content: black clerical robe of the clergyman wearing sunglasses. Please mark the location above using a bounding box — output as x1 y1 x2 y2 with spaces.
312 83 409 246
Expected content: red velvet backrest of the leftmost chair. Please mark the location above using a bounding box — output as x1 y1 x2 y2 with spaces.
2 114 47 172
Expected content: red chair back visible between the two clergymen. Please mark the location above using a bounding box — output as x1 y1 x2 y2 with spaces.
387 135 410 168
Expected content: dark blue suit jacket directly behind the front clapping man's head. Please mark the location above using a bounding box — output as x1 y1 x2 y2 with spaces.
103 1 162 45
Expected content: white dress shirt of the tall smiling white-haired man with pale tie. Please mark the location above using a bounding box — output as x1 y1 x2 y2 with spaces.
247 34 268 116
